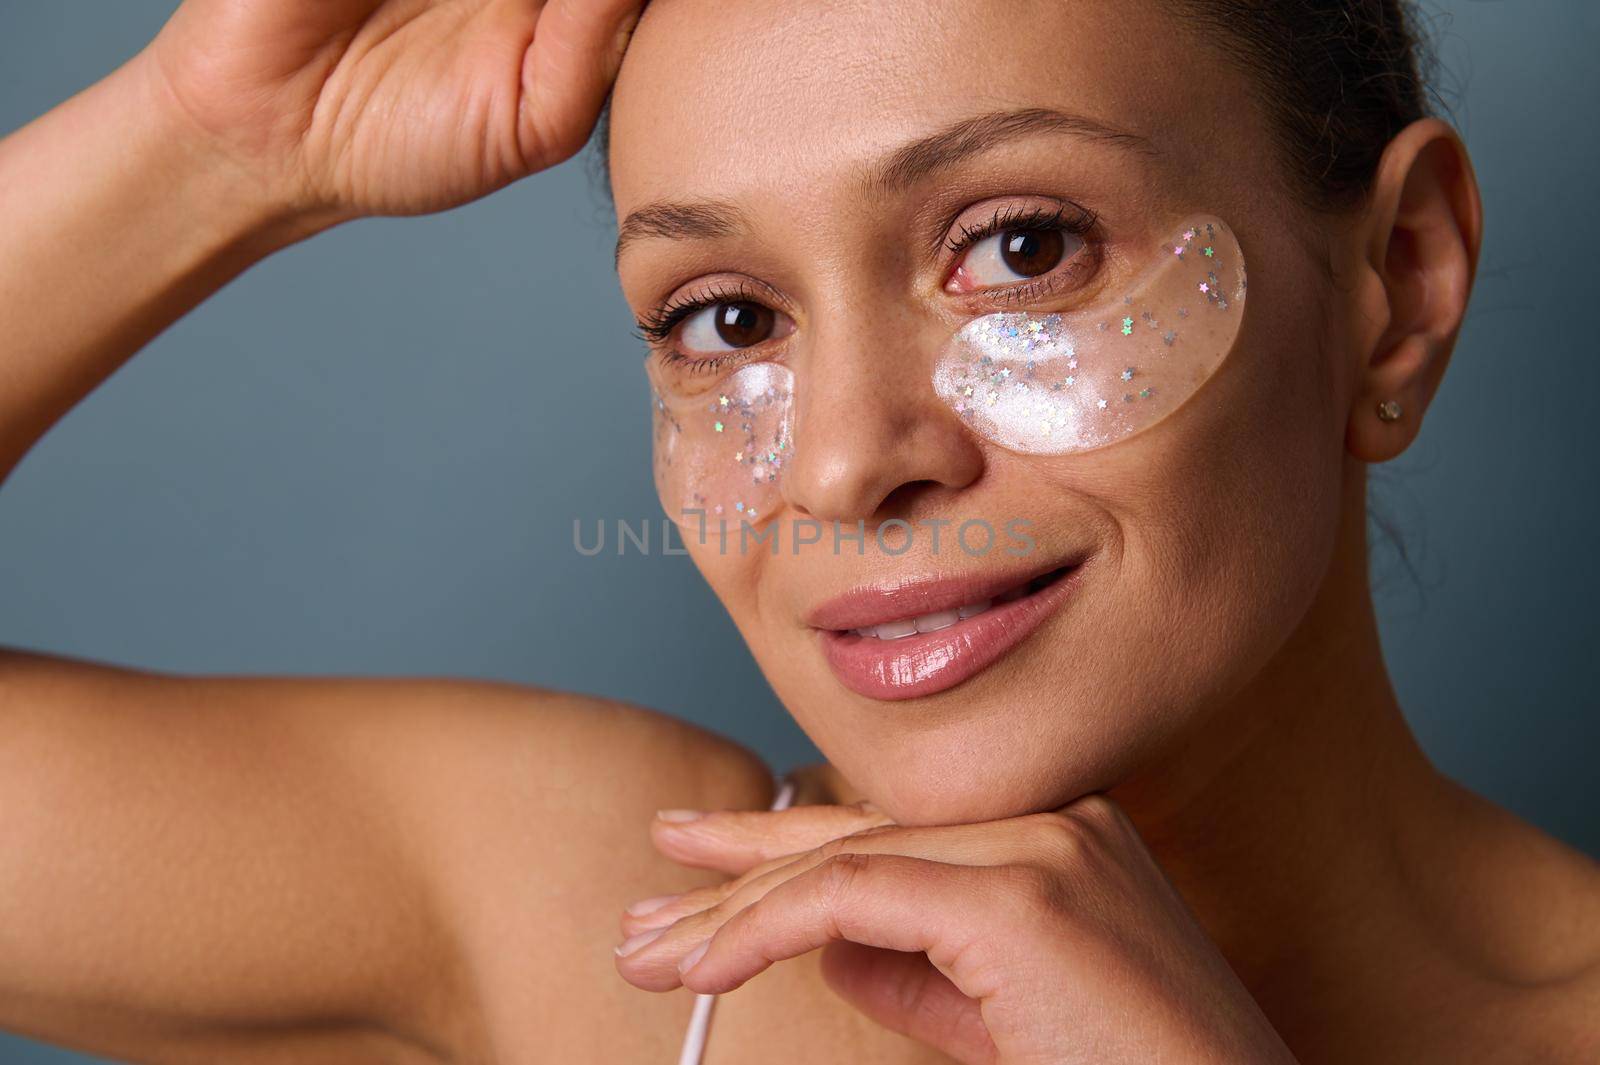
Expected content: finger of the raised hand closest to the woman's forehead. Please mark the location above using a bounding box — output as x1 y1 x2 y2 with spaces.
522 0 648 161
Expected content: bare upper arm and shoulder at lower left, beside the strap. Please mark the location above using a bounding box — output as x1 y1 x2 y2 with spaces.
0 649 773 1065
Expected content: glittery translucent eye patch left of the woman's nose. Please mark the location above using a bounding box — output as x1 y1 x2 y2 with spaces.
646 361 794 529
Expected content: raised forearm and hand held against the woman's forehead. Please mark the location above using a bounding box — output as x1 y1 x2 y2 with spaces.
0 0 643 481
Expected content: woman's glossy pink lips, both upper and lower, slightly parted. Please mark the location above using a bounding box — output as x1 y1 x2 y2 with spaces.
811 564 1083 700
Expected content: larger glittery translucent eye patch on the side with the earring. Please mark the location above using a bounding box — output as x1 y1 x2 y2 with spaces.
933 217 1245 454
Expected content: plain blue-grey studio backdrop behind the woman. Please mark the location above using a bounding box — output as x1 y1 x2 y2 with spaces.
0 0 1600 1065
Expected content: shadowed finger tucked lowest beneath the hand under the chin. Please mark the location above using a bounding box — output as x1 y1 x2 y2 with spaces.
822 939 998 1065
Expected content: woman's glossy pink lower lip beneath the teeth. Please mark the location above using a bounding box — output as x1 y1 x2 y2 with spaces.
821 566 1082 699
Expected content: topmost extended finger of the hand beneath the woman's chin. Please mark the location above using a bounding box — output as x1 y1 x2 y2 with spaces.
650 801 894 876
